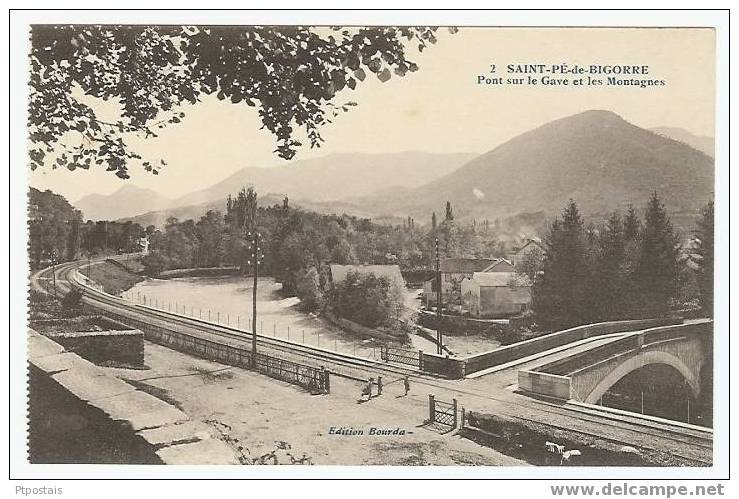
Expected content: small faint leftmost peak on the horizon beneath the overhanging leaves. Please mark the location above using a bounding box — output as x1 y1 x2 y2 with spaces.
75 184 172 220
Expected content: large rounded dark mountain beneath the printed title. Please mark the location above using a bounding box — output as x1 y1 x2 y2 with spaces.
366 111 714 225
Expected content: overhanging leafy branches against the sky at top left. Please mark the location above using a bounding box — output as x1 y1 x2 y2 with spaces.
28 25 455 178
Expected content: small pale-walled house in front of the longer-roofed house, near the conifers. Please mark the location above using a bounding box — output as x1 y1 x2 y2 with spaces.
461 271 531 318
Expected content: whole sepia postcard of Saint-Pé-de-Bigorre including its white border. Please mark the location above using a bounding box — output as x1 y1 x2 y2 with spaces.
10 5 729 486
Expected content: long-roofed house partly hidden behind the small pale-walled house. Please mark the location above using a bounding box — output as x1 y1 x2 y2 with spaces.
423 258 513 306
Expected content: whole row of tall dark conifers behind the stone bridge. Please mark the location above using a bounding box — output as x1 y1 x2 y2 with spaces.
532 192 713 329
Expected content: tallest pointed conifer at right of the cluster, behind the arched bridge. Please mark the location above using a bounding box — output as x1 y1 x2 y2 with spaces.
634 191 678 314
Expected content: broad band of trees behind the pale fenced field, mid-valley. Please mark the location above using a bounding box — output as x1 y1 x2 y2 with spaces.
144 189 425 282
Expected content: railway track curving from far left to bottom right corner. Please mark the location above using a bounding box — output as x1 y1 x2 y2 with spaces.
31 260 713 466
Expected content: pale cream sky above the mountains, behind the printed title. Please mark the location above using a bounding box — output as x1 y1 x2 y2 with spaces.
29 28 715 202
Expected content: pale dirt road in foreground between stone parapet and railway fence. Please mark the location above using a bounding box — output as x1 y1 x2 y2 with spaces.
111 343 526 466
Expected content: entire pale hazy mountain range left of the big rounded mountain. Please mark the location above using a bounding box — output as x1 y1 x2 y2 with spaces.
75 151 475 220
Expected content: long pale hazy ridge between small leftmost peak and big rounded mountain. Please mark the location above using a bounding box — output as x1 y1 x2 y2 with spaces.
172 151 475 207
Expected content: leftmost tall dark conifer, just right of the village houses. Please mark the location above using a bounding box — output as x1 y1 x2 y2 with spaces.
532 200 592 329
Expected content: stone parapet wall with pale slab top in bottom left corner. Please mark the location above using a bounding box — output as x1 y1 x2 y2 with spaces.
28 330 238 464
